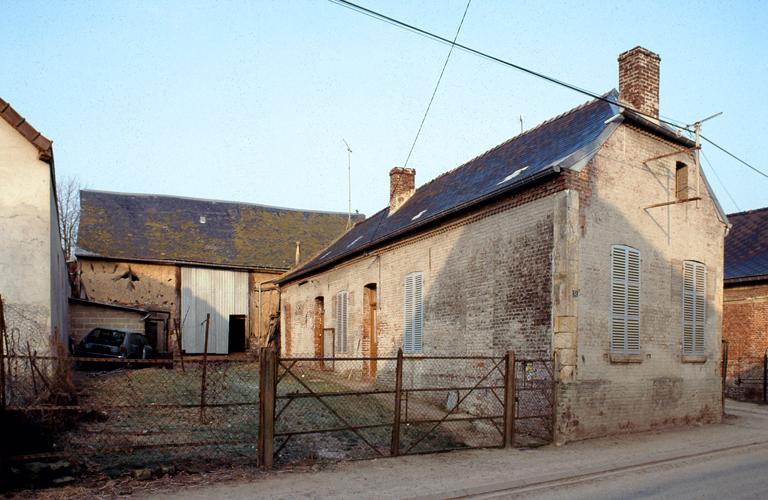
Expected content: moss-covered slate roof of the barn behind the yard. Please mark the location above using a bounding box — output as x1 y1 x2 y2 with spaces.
76 190 363 271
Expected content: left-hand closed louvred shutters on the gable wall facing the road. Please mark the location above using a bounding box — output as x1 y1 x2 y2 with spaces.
611 245 640 354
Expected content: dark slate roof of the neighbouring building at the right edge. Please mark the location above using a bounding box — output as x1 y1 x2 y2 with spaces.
725 207 768 282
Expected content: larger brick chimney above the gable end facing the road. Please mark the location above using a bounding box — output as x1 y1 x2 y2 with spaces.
619 46 661 119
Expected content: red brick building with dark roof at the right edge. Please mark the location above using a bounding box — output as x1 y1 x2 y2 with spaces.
723 208 768 400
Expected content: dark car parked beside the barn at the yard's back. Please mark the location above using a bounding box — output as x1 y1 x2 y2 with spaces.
75 328 154 359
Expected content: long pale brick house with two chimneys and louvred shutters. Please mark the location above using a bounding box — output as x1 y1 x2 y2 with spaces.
276 47 727 442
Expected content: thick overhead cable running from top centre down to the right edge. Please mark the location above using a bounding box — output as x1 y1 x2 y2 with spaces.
329 0 768 178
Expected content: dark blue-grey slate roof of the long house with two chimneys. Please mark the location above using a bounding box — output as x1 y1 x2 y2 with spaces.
276 90 628 283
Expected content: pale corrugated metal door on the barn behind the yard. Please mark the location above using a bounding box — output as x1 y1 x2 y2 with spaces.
181 267 248 354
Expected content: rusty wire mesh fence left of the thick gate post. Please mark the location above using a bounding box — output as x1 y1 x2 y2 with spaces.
3 356 259 474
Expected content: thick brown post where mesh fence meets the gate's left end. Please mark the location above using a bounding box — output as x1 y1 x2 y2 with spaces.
259 347 277 469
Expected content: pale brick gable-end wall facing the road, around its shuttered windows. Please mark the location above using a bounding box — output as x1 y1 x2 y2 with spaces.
556 125 725 442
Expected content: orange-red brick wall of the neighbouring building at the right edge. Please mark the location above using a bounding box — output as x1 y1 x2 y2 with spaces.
723 283 768 401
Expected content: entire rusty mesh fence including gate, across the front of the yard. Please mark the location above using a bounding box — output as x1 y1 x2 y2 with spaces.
0 348 556 484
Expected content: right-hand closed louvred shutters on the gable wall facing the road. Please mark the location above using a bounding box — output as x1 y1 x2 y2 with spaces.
683 260 707 356
